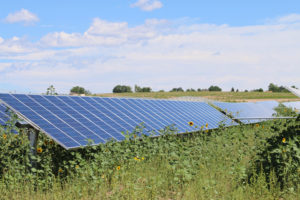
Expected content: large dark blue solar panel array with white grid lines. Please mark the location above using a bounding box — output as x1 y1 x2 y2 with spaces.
0 94 236 149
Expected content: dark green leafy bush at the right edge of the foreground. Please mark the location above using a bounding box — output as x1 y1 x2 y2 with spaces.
254 115 300 190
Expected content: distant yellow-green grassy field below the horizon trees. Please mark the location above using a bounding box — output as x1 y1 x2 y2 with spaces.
97 91 300 101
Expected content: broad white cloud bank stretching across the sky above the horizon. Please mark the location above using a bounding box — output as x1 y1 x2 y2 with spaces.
0 14 300 93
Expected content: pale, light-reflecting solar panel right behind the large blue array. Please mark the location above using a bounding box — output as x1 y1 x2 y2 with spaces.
214 101 278 124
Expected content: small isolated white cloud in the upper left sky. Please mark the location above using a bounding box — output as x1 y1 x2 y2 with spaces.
4 8 39 25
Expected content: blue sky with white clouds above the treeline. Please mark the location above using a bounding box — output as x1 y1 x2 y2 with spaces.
0 0 300 93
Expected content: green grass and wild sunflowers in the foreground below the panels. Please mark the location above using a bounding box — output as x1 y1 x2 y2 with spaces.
0 116 300 200
